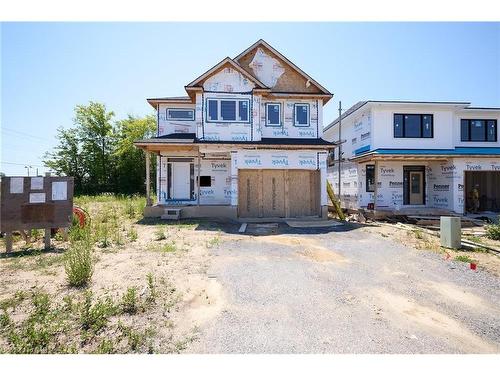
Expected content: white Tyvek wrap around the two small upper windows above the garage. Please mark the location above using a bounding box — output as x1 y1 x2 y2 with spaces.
260 100 322 138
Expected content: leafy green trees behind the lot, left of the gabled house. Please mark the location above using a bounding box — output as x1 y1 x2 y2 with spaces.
44 102 156 194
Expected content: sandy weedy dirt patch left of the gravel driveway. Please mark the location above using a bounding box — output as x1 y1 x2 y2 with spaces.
0 200 229 353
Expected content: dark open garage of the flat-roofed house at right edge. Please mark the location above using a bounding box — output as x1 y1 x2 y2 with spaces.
463 171 500 213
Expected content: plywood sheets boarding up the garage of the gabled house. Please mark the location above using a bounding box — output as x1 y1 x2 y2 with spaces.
238 169 321 218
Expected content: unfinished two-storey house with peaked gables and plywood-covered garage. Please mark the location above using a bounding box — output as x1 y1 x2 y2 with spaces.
135 40 334 218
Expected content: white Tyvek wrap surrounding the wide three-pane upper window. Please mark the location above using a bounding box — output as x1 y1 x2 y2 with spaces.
199 93 254 141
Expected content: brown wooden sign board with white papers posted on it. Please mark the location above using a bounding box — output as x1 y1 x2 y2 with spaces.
0 176 74 232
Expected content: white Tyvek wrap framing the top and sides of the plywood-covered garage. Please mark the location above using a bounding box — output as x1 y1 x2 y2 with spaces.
231 150 328 206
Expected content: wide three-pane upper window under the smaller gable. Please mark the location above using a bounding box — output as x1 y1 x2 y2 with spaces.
207 99 250 122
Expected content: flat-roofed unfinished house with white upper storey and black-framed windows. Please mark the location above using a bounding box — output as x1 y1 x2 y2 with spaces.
324 100 500 214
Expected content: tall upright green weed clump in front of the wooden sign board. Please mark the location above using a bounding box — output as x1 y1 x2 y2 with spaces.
64 238 94 287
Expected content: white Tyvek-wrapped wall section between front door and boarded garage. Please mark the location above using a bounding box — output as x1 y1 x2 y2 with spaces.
194 160 231 205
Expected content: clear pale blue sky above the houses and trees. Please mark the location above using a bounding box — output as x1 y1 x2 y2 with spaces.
0 22 500 175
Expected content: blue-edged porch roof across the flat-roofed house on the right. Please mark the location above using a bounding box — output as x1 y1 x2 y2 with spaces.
351 147 500 161
